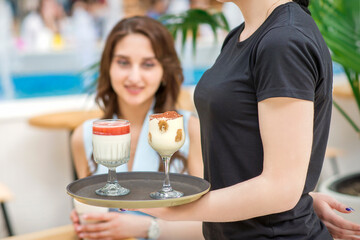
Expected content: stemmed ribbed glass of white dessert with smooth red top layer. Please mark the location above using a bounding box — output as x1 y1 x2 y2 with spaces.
92 119 131 196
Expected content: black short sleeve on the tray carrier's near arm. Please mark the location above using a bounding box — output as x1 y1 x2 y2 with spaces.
253 26 317 102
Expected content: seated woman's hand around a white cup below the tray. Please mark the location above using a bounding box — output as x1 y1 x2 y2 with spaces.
71 211 151 240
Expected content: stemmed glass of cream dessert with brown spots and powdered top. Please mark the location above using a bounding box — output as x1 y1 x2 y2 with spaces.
148 111 185 199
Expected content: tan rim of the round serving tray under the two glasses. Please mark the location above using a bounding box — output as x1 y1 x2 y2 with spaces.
66 171 211 208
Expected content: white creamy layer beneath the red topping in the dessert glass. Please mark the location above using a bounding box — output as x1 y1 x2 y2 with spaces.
92 133 131 165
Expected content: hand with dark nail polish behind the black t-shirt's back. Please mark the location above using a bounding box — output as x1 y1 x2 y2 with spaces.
311 193 360 240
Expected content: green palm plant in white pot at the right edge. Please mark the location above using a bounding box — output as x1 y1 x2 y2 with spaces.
310 0 360 222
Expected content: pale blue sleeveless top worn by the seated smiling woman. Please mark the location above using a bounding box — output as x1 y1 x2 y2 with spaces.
83 109 192 175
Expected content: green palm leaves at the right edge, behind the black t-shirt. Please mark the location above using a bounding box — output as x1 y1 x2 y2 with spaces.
310 0 360 133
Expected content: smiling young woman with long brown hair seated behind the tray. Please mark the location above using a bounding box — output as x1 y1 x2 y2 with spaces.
71 17 203 239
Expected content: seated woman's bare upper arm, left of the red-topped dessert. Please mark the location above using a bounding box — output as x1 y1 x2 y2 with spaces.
71 125 91 178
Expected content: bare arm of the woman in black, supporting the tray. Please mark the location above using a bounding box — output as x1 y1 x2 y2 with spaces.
139 98 314 222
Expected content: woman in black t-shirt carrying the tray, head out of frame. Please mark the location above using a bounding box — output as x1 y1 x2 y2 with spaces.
138 0 360 240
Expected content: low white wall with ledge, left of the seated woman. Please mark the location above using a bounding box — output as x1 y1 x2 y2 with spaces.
0 96 97 238
